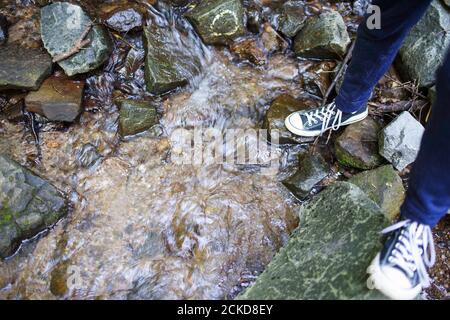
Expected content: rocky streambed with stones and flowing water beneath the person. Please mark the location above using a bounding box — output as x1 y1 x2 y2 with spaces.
0 0 450 299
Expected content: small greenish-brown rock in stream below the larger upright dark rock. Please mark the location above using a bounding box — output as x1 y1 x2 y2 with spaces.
117 100 158 137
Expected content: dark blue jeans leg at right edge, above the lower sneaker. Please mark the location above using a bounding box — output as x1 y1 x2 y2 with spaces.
401 51 450 226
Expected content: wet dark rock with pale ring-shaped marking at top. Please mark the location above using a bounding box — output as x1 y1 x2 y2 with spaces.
186 0 245 44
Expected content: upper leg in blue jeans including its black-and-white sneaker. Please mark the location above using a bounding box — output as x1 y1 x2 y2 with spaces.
285 0 432 137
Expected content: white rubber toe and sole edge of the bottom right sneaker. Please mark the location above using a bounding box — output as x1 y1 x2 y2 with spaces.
367 254 422 300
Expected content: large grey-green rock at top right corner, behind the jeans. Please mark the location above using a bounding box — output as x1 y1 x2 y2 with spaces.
397 1 450 87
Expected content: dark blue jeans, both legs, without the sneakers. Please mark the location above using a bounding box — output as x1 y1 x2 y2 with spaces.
336 0 450 226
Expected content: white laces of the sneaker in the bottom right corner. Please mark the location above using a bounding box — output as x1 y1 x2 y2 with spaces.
381 220 436 287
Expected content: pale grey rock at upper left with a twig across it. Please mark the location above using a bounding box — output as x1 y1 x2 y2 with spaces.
41 2 112 76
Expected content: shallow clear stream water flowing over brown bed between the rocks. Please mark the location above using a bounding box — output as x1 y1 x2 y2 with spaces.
0 0 322 299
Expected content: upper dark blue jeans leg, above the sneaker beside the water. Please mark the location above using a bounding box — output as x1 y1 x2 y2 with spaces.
336 0 432 113
